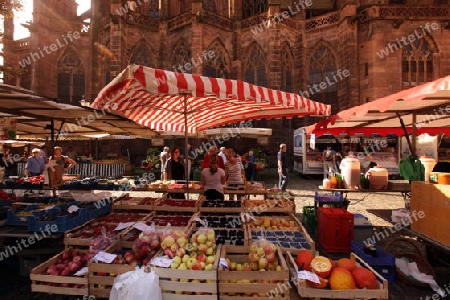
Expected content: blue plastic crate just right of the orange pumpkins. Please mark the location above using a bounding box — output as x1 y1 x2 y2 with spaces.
351 241 395 283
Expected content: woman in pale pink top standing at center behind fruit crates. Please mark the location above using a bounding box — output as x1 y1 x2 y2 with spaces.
201 154 225 200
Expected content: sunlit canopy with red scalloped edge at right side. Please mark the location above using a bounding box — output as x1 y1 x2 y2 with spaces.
306 76 450 136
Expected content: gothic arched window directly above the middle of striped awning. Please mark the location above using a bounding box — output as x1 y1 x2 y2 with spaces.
203 40 230 78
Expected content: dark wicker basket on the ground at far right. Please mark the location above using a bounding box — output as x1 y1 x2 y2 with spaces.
384 238 436 287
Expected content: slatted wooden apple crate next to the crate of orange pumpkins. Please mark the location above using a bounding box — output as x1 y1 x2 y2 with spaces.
218 245 290 300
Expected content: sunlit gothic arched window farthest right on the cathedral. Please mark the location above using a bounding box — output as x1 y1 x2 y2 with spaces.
402 37 433 87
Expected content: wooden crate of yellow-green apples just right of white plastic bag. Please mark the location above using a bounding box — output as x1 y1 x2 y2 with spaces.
152 245 221 300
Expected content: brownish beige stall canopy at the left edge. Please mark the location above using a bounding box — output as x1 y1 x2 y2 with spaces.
0 84 157 139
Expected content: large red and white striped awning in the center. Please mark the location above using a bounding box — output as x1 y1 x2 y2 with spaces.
91 65 331 133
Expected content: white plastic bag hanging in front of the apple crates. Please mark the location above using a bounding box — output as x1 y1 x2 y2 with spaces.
109 267 162 300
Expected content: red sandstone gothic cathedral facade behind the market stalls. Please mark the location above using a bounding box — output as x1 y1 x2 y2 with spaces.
5 0 450 164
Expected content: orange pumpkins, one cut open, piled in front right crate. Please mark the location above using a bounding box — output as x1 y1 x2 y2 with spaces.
295 250 380 290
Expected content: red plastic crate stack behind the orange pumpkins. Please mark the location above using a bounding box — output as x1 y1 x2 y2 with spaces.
317 208 354 252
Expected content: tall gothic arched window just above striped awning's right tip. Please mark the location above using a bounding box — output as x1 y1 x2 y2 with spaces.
306 44 339 113
